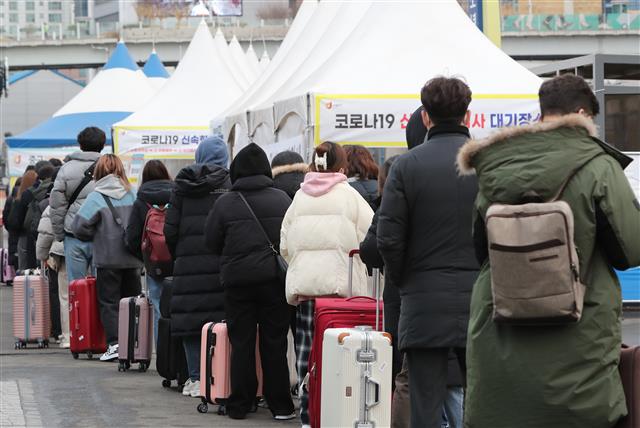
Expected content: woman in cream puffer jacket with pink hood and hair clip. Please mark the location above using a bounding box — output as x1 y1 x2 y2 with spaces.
280 141 373 428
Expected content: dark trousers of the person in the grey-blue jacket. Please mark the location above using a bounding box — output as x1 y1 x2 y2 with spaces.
96 268 141 345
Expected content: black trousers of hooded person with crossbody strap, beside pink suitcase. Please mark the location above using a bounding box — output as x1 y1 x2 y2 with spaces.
225 284 294 415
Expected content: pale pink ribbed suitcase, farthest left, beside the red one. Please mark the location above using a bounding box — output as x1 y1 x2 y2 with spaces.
13 270 51 349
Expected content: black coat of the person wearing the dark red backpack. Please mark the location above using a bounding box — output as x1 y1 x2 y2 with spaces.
126 180 173 260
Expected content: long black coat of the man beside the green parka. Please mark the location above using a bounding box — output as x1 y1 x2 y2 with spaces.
378 126 479 351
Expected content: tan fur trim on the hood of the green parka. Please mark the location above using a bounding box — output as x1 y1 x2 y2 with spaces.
456 113 598 175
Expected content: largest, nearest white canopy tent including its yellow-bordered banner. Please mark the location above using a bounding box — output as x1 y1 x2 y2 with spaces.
227 0 541 160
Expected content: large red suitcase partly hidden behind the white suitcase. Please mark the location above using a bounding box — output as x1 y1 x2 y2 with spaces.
308 250 384 428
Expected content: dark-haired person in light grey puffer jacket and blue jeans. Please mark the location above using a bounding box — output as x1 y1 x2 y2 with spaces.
49 126 106 282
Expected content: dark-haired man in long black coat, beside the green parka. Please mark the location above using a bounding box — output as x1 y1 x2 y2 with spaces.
378 77 478 428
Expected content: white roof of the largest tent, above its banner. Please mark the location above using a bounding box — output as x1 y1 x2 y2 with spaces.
277 0 540 99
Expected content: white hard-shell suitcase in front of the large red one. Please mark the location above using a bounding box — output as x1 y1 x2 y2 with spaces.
320 326 393 428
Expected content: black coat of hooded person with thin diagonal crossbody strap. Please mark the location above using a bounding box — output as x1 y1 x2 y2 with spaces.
206 175 291 290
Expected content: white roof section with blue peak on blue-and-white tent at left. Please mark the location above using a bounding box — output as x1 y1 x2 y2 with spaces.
53 42 155 117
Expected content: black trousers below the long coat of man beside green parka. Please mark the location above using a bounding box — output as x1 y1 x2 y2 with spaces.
406 348 467 428
